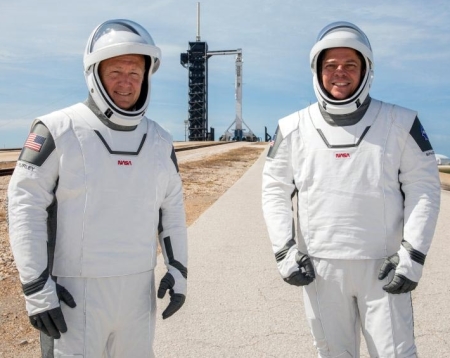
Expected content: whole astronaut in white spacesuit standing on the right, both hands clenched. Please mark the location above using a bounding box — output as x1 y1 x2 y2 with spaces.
262 22 440 358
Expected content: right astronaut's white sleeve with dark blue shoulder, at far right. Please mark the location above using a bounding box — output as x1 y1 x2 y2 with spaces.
399 117 441 258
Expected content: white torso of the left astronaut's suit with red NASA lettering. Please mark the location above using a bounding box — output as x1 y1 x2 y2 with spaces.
49 104 170 277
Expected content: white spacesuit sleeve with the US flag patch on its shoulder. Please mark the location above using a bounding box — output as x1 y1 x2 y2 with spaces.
8 121 58 314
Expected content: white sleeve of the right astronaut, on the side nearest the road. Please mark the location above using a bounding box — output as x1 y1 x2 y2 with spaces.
262 127 296 268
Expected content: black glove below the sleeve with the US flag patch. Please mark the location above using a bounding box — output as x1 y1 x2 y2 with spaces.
29 284 76 339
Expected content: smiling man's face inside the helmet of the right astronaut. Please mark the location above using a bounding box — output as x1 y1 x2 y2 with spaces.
321 47 362 100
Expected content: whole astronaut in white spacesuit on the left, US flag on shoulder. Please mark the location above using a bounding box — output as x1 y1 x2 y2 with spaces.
8 20 187 358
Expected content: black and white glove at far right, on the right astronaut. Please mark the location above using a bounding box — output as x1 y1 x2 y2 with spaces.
378 245 425 294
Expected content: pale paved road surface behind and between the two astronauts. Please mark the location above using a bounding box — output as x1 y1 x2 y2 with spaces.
154 153 450 358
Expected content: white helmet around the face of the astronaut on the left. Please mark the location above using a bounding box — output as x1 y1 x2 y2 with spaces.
83 19 161 126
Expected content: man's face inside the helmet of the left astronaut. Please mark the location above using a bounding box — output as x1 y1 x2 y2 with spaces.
99 55 145 110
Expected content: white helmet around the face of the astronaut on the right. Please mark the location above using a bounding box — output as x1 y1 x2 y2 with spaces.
309 21 374 114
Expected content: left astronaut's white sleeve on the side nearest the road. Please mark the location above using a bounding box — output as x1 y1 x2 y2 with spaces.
158 148 188 294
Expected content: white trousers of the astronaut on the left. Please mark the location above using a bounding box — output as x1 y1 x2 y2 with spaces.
54 271 156 358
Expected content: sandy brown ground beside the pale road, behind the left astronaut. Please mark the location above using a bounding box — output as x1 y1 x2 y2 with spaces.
0 143 265 358
